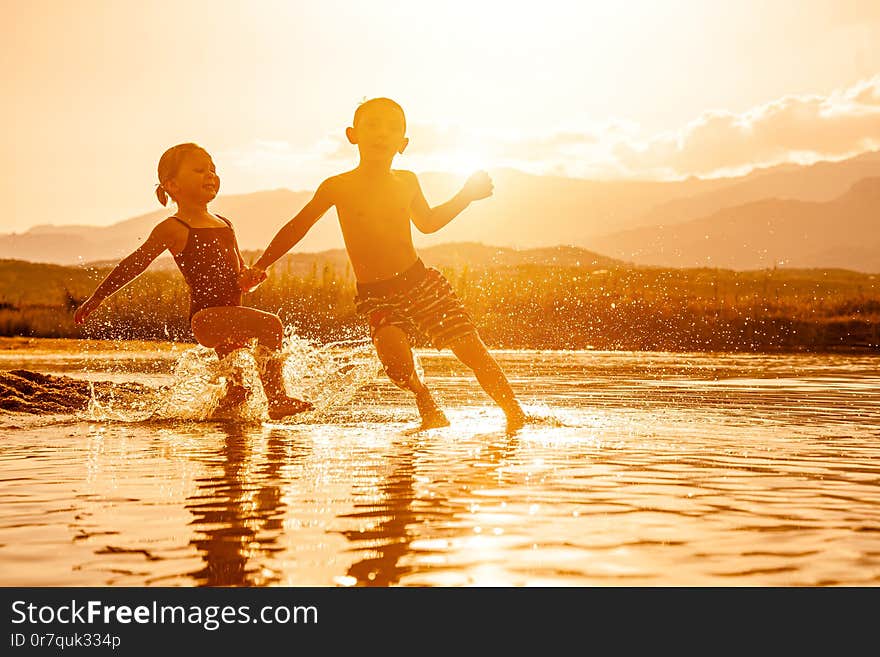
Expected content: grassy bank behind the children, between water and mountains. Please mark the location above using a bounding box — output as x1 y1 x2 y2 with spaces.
0 260 880 351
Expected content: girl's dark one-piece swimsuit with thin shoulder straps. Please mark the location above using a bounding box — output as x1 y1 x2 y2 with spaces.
172 215 241 319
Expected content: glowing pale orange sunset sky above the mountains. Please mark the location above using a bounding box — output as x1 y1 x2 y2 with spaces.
0 0 880 233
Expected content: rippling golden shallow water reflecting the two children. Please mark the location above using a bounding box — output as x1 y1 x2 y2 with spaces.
0 343 880 586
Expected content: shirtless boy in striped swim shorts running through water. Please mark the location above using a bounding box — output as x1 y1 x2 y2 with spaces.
240 98 525 433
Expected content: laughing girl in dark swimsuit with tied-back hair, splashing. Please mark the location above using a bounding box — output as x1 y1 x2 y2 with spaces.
74 143 312 420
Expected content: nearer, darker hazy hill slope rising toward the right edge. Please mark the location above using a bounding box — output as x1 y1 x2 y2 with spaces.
591 177 880 272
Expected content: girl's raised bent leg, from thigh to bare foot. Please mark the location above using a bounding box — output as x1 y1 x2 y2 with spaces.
192 306 312 419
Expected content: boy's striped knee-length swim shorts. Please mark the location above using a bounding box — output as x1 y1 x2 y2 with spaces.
354 260 477 349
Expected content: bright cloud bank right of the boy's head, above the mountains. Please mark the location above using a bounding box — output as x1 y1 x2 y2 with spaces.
394 75 880 179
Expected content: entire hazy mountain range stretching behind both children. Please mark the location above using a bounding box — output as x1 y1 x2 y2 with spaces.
0 151 880 272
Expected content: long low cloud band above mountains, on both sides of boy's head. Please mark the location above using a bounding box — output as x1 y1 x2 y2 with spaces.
221 75 880 189
